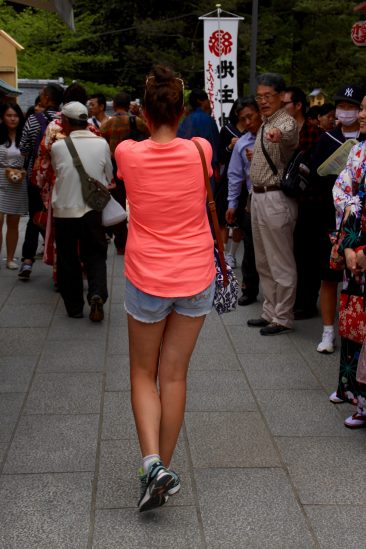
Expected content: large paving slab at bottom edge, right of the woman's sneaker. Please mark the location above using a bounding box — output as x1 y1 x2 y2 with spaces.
195 469 316 549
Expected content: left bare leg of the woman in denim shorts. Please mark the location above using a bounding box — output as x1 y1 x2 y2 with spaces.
128 315 166 456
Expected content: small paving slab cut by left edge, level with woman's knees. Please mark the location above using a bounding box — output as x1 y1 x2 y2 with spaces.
0 356 37 398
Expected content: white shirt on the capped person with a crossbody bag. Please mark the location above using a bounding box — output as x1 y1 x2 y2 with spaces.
51 130 113 218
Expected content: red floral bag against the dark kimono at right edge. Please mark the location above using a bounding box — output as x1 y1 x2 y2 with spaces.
338 277 366 343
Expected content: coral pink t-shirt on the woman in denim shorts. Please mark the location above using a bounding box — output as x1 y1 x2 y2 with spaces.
115 138 216 297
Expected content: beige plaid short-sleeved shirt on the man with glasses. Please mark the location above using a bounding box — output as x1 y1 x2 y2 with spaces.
250 109 299 187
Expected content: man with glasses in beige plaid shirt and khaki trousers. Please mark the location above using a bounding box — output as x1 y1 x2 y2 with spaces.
248 73 299 336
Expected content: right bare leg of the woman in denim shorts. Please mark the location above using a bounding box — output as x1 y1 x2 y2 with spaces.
159 312 205 466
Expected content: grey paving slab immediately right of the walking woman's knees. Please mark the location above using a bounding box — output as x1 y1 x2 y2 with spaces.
186 370 257 411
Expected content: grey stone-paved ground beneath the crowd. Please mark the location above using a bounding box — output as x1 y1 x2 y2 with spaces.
0 221 366 549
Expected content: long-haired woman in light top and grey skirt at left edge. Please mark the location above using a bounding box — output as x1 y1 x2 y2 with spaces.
0 103 28 270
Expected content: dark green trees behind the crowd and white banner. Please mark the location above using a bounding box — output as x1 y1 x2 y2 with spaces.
0 0 366 97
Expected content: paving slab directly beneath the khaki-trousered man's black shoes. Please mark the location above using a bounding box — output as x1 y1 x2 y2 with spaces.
227 326 291 355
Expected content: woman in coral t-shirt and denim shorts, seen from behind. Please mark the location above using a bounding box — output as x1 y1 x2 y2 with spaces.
115 66 215 511
